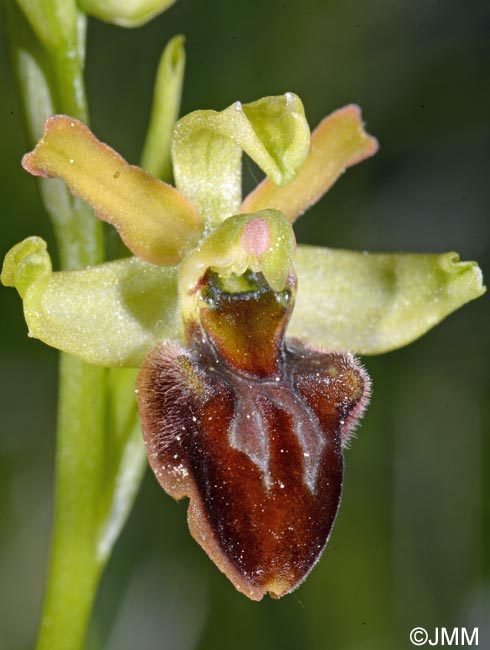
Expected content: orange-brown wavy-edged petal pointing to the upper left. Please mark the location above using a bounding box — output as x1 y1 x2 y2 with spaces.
22 115 202 265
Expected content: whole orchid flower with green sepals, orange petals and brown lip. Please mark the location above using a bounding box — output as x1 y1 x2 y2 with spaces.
1 93 485 600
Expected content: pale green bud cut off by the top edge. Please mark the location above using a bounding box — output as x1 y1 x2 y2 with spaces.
78 0 175 27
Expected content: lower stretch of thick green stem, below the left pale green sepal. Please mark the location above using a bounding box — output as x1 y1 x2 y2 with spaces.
36 354 105 650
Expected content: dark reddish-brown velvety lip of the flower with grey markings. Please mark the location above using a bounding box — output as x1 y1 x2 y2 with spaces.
138 264 369 600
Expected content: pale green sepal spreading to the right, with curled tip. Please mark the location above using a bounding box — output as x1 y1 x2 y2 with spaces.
288 246 485 354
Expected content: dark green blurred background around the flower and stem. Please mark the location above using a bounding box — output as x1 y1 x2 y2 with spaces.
0 0 490 650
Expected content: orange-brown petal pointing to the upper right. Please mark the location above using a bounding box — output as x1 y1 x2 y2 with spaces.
240 105 378 222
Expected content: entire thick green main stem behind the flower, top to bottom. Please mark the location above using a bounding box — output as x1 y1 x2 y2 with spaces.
4 0 106 650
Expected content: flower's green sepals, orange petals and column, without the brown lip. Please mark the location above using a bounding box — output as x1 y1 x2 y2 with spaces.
1 92 485 367
